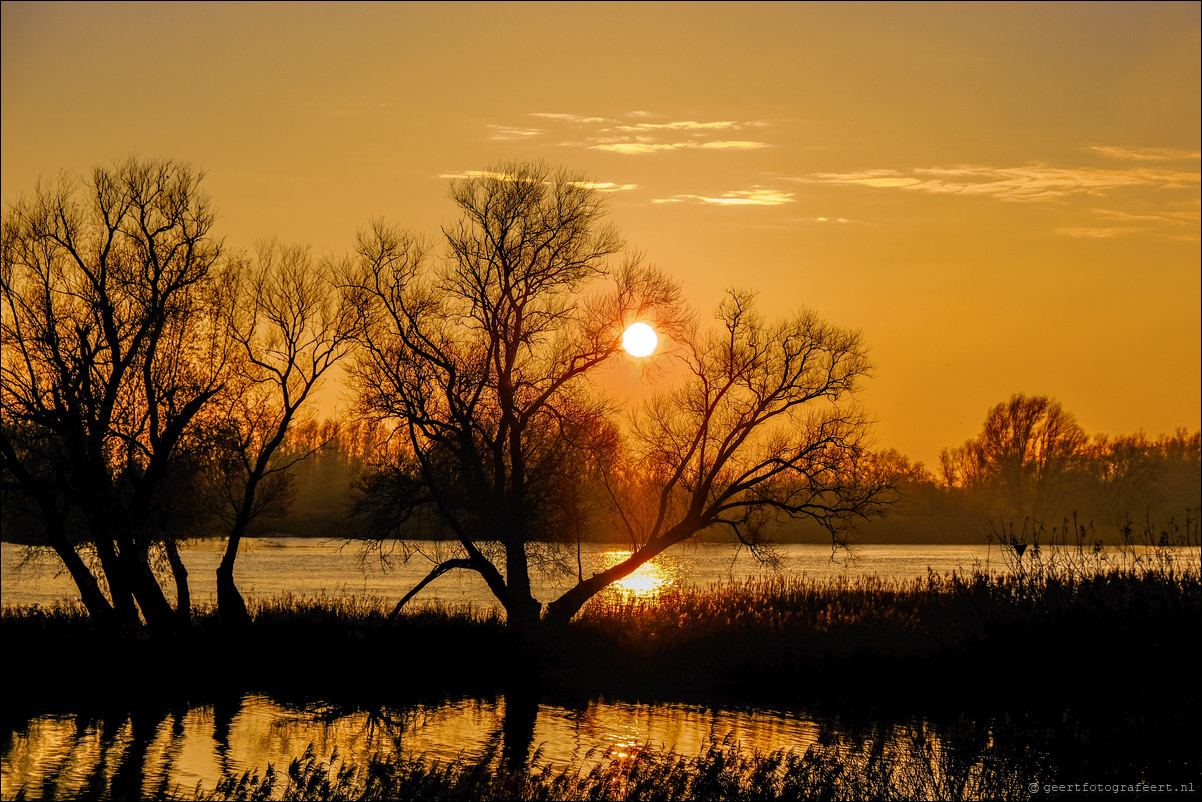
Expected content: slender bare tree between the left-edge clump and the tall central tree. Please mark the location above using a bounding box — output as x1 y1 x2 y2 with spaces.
216 243 355 625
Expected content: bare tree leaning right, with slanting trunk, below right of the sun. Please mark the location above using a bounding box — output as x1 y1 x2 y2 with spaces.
546 292 892 622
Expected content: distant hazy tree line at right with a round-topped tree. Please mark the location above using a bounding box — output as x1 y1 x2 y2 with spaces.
861 394 1202 546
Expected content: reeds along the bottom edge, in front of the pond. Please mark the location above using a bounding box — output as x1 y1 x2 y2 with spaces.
180 725 1040 802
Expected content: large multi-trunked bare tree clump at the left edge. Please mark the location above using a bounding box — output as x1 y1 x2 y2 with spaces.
0 159 224 626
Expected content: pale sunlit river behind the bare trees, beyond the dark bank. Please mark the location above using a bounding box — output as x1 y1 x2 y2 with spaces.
0 537 1007 607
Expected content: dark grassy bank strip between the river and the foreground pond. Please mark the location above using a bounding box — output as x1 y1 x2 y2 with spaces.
0 566 1202 707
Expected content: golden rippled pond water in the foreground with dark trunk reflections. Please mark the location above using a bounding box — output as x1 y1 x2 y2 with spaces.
0 693 819 798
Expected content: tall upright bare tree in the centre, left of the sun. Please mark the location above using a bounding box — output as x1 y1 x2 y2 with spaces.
349 164 680 630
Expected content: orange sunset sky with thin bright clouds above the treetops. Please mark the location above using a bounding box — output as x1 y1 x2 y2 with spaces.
0 1 1202 464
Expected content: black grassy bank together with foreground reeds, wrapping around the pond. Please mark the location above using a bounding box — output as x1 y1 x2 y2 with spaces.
0 565 1202 800
